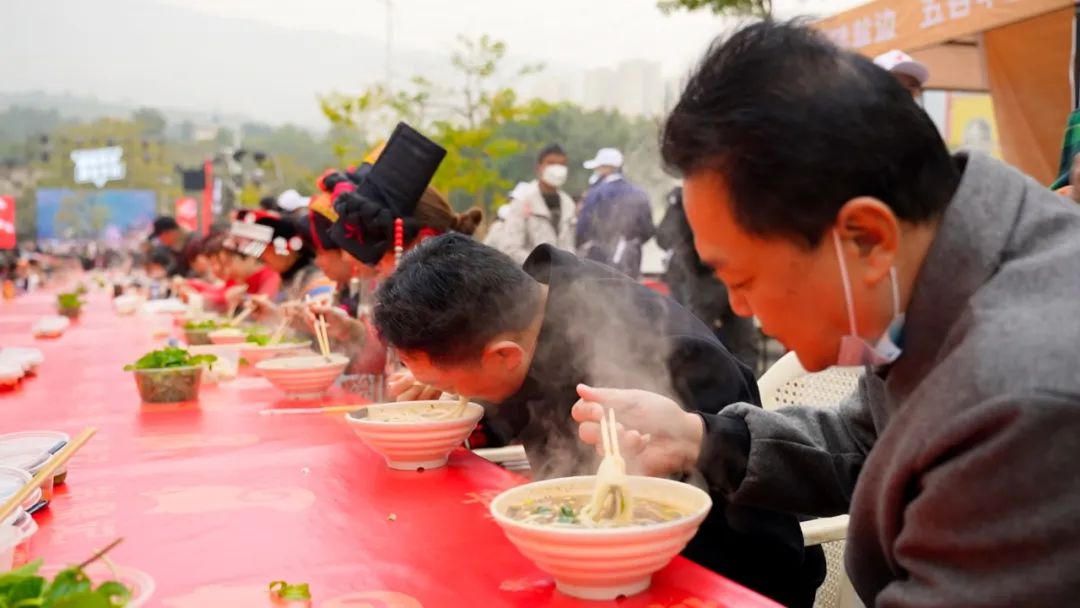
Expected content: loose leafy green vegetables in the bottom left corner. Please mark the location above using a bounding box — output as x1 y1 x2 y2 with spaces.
0 559 132 608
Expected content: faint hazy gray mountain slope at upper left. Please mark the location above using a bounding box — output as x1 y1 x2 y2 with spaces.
0 0 427 126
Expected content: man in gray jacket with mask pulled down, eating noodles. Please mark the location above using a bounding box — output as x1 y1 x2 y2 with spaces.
573 23 1080 608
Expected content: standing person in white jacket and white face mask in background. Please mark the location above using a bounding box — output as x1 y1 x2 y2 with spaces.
488 144 577 264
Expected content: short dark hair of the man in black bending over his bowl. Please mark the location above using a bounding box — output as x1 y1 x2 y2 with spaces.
375 233 540 364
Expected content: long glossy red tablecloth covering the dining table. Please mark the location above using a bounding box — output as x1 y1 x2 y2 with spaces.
0 294 775 608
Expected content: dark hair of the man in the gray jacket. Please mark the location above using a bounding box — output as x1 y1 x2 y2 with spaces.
661 22 960 247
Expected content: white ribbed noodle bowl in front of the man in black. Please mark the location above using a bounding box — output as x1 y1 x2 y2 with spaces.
346 401 484 471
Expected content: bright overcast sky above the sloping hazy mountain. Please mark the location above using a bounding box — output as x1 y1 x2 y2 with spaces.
154 0 860 72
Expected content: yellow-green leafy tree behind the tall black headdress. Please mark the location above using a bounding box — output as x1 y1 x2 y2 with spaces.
320 35 551 213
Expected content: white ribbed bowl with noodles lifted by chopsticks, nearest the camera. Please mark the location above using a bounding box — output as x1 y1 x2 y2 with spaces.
490 475 713 600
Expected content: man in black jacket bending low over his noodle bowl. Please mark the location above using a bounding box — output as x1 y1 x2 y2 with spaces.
375 234 824 606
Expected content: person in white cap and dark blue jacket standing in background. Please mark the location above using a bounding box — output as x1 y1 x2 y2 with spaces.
575 148 656 280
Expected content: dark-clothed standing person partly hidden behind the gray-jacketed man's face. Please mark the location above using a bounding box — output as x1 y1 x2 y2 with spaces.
657 187 761 370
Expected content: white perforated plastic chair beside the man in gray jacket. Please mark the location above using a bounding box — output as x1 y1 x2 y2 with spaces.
757 352 863 608
